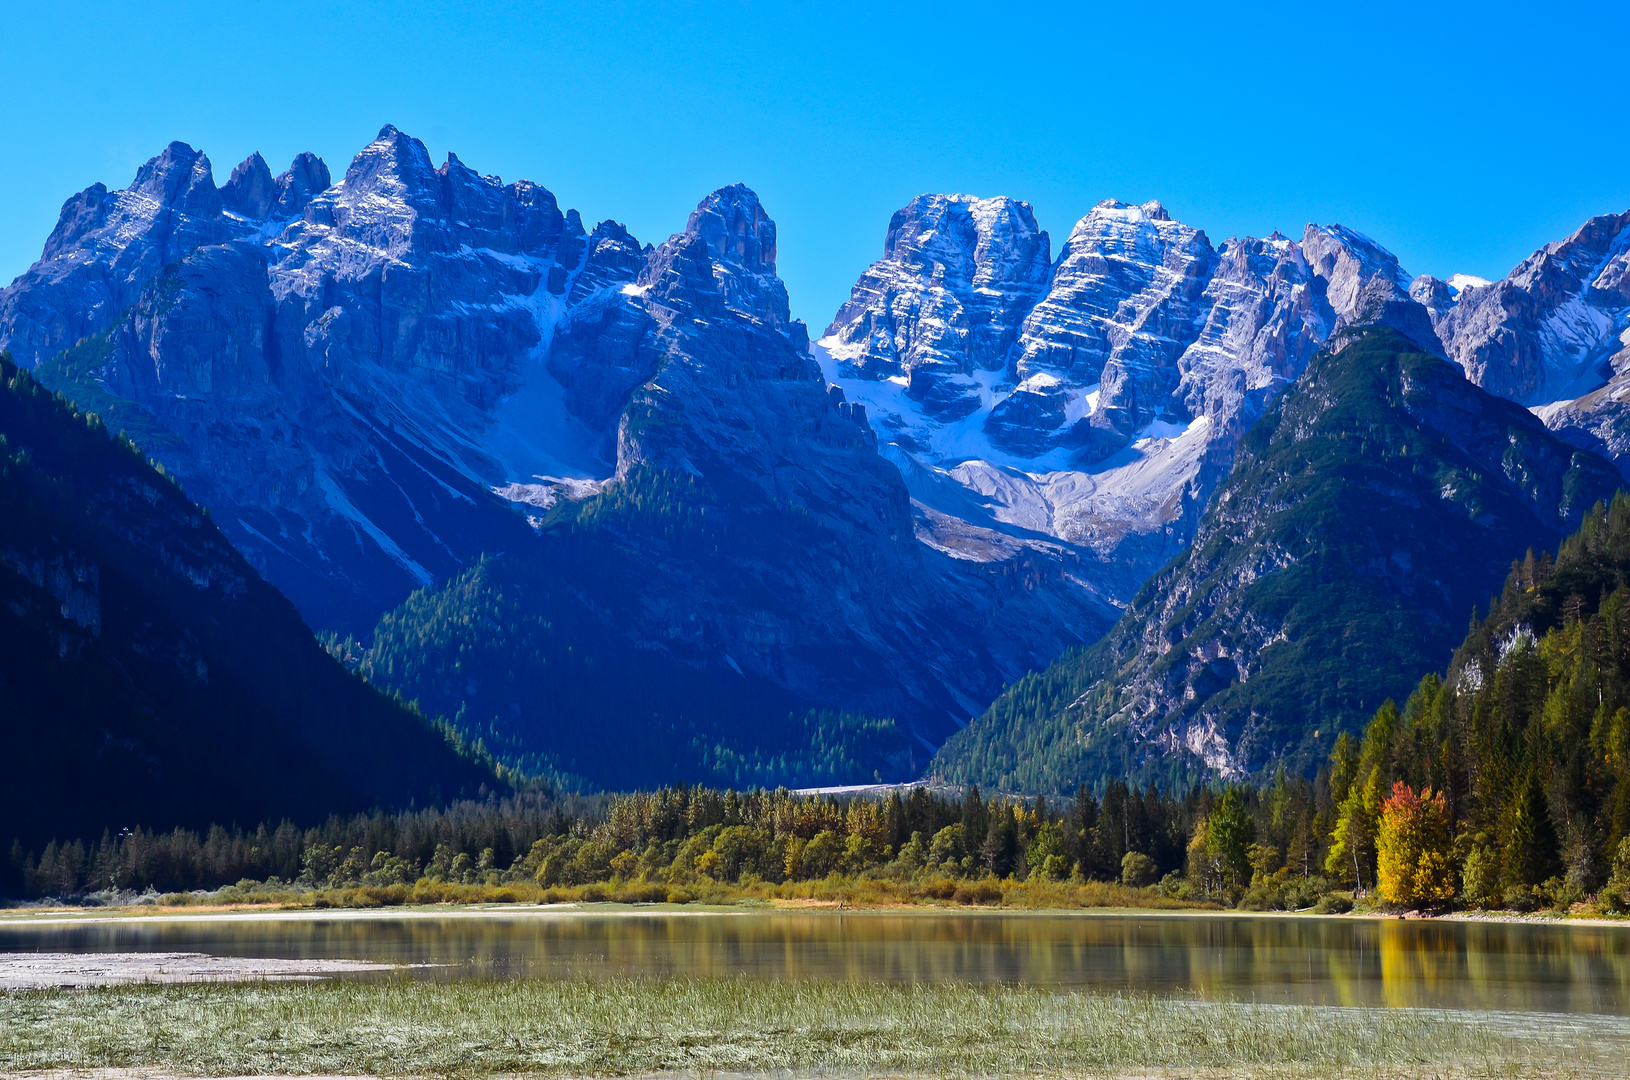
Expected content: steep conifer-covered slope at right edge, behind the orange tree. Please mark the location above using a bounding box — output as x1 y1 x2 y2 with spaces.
1330 494 1630 907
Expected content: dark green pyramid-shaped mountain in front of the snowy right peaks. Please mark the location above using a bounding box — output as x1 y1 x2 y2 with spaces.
931 329 1619 793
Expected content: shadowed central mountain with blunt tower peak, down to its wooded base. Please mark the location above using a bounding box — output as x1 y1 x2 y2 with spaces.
342 186 1108 784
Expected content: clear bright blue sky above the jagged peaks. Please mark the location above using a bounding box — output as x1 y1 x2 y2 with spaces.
0 0 1630 331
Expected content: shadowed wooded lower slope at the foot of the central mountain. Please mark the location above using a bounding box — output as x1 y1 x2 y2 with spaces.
355 534 927 790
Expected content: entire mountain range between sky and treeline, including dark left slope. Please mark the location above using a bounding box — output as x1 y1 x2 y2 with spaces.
0 127 1630 824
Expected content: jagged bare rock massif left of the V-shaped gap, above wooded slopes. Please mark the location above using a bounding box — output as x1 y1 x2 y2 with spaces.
0 127 1110 768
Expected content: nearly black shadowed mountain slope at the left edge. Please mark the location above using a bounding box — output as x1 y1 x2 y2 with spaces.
0 353 500 844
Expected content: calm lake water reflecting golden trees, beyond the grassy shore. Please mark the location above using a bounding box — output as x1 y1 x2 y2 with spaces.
0 911 1630 1016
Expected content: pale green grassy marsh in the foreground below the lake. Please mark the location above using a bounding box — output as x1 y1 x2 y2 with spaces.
0 977 1630 1077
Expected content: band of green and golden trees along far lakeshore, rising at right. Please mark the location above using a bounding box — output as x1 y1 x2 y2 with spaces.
5 495 1630 914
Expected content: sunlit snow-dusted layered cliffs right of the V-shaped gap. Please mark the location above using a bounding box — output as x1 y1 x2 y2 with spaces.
818 195 1443 599
